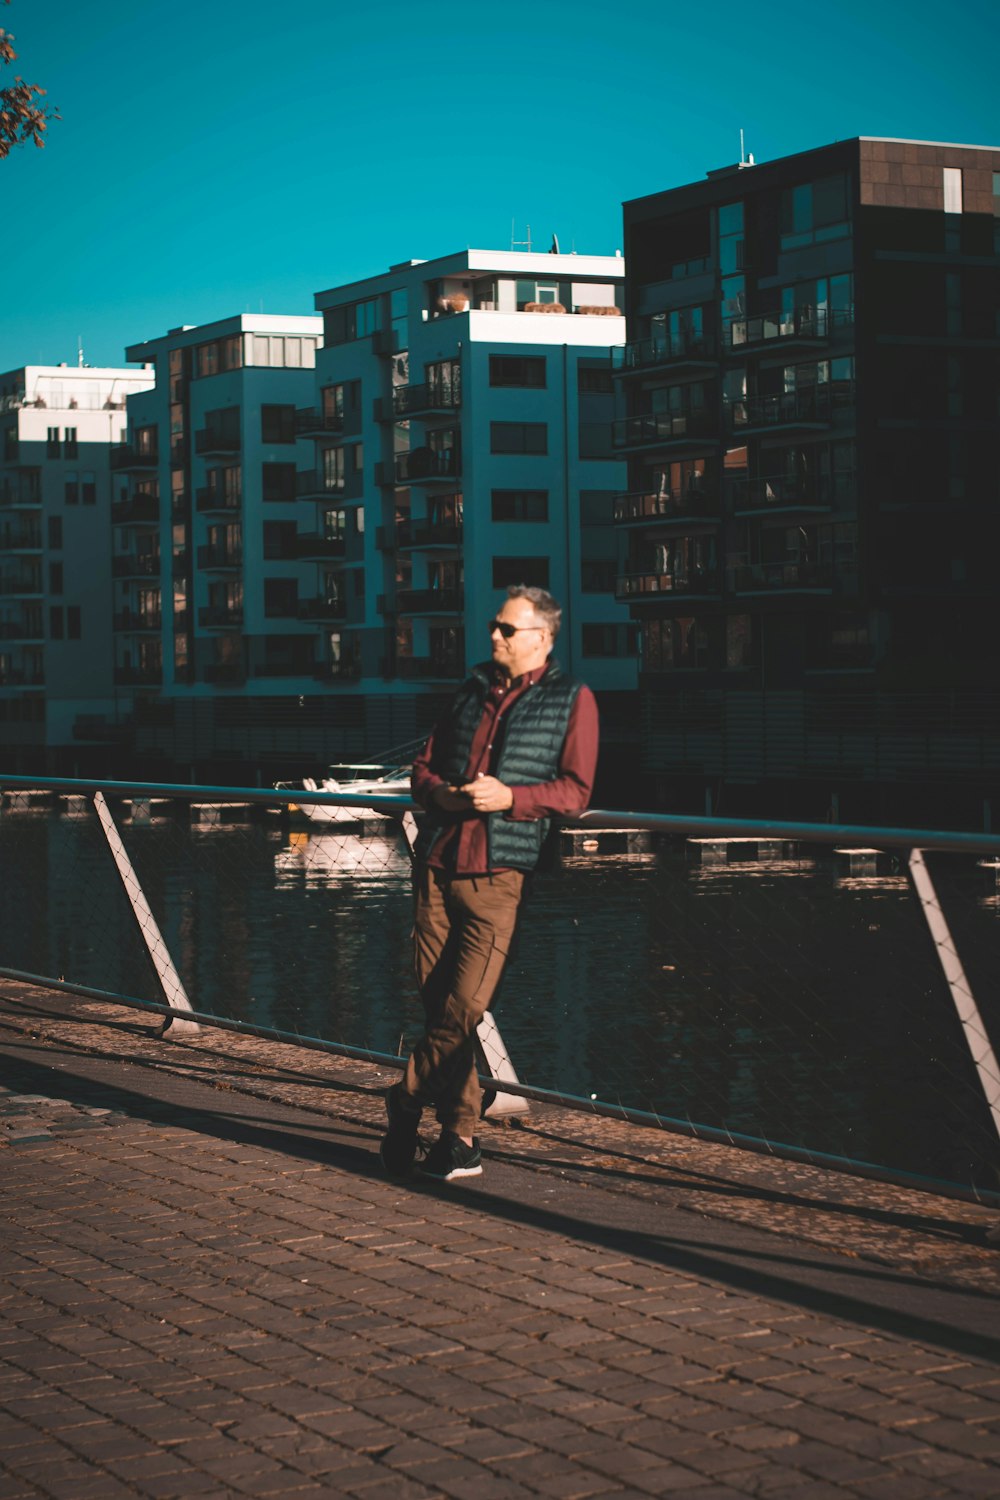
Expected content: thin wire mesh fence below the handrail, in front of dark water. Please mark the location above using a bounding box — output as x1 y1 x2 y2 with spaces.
0 783 1000 1191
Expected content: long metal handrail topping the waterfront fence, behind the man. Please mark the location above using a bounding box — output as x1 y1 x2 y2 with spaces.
0 771 1000 855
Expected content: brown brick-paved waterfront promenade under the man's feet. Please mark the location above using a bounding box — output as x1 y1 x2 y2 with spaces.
0 981 1000 1500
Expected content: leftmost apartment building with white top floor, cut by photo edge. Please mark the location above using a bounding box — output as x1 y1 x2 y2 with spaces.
0 365 151 774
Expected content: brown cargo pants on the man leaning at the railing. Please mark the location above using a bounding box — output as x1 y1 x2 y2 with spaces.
403 867 525 1136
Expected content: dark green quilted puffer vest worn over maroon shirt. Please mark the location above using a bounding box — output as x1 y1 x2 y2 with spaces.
417 660 580 870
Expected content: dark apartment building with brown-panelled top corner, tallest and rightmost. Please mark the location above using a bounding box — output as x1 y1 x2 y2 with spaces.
613 138 1000 827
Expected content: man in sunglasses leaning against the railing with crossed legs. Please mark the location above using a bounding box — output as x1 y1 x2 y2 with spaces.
381 585 598 1182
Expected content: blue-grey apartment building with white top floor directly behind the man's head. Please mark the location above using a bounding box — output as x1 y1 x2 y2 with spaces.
312 249 636 762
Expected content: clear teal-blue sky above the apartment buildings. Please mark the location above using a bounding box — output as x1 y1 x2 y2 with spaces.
0 0 1000 371
